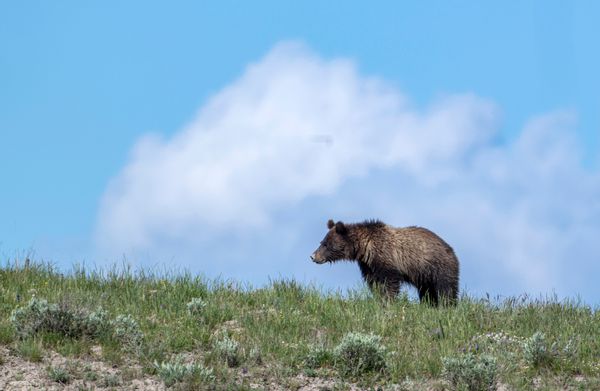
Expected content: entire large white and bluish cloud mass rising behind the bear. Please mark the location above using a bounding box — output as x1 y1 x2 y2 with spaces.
96 43 600 300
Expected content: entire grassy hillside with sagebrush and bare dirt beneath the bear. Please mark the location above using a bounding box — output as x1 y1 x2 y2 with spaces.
0 264 600 390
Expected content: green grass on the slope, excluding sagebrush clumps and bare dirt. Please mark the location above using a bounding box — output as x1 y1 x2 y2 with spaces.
0 264 600 389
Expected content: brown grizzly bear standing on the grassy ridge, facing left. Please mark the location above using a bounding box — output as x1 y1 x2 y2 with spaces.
310 220 458 306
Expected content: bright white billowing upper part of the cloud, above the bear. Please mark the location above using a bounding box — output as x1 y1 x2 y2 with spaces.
94 43 495 251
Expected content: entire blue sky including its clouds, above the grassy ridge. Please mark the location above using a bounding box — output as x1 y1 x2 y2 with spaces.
0 1 600 303
